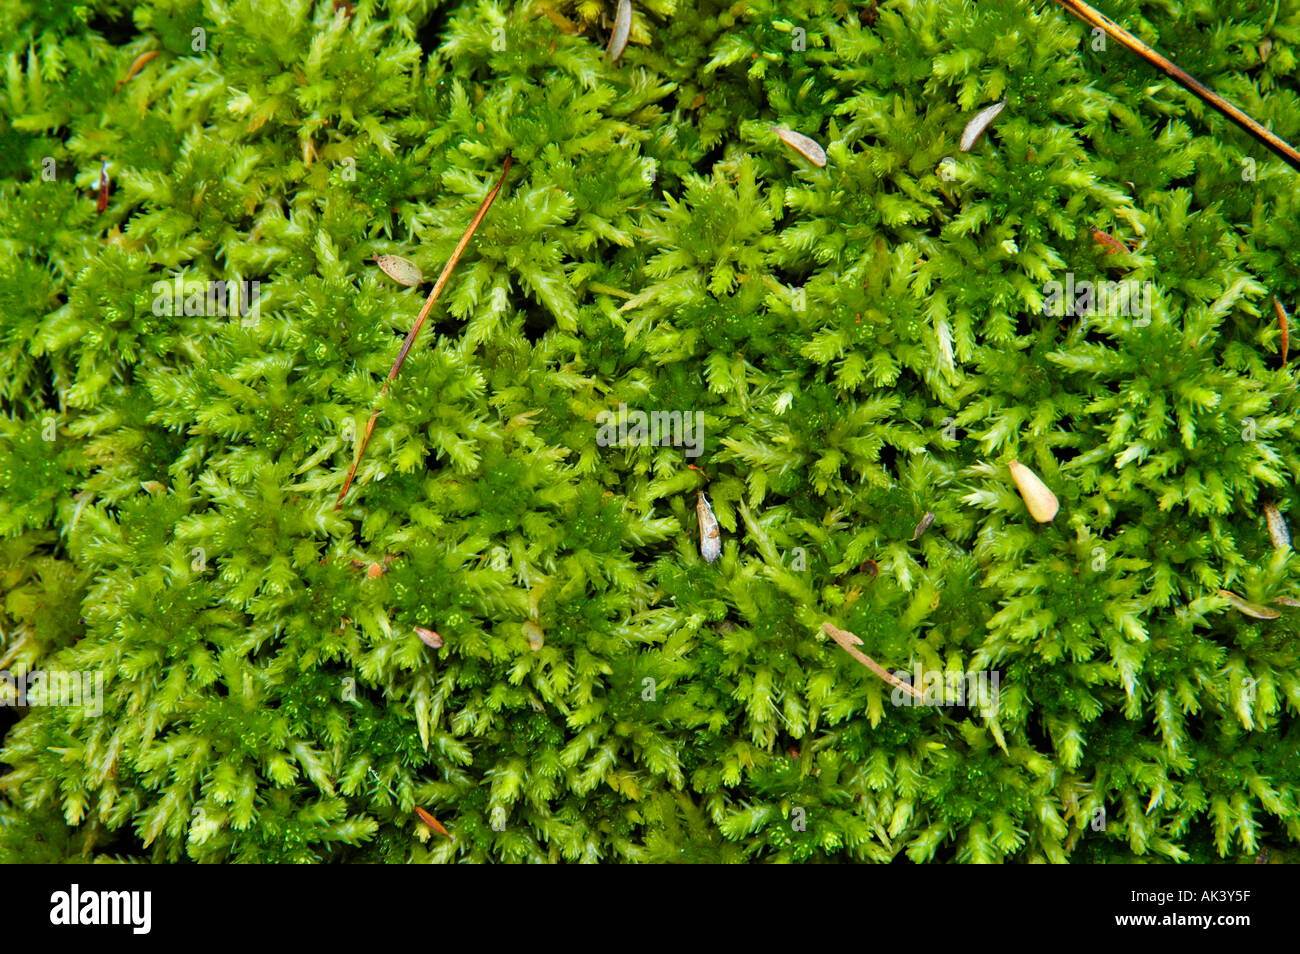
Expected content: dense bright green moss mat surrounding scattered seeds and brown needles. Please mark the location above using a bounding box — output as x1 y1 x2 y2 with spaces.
0 0 1300 862
